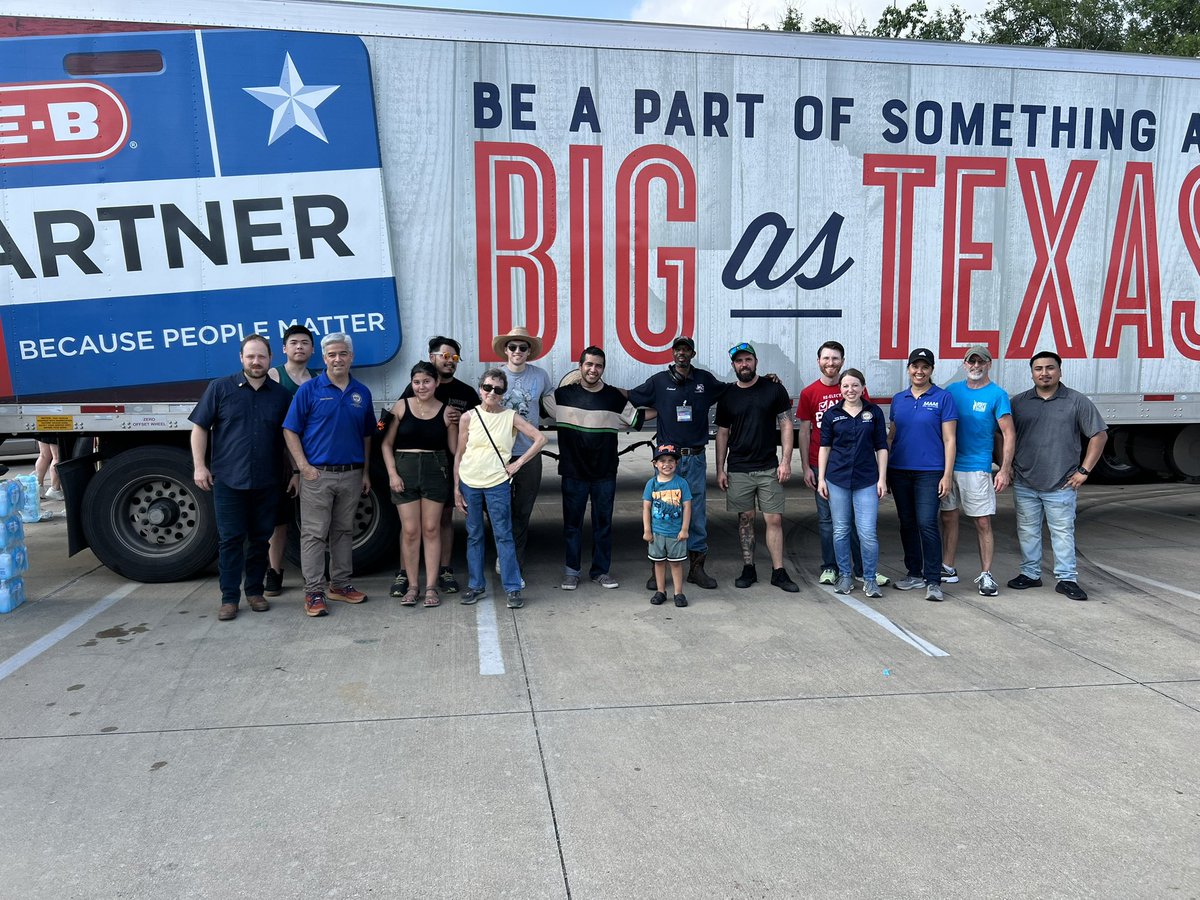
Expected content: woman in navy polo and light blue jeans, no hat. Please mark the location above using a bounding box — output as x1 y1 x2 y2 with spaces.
817 368 888 598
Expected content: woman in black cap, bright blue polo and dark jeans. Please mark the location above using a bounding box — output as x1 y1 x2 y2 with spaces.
888 347 959 600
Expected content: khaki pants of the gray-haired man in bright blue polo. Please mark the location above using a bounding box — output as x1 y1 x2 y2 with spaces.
300 469 362 594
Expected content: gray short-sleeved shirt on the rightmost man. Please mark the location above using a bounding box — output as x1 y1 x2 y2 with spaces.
1013 384 1108 491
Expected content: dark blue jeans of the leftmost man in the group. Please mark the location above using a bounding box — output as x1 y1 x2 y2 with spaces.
212 481 280 605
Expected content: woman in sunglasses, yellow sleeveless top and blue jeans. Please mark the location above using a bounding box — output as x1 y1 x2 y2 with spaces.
454 368 546 610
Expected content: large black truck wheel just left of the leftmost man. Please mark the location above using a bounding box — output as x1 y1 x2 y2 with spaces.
83 446 217 582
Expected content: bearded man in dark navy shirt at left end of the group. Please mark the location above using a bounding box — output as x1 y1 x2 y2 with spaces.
188 335 292 622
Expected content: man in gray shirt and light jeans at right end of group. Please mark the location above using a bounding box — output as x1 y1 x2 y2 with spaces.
1008 350 1109 600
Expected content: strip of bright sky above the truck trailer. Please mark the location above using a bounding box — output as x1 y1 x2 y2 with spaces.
386 0 986 32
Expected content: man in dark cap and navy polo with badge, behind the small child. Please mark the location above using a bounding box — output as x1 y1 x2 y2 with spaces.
629 336 730 590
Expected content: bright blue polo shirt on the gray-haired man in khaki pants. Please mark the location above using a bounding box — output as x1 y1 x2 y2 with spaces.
283 372 376 466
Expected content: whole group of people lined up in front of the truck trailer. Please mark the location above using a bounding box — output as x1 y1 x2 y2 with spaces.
184 325 1105 620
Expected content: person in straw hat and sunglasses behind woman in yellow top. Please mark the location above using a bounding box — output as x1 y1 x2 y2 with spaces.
492 325 554 578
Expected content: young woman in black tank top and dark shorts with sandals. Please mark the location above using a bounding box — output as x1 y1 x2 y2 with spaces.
383 362 458 606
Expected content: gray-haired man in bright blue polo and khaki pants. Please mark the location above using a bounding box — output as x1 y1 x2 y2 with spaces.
283 331 376 616
